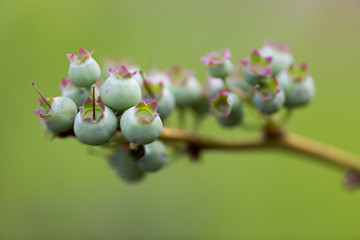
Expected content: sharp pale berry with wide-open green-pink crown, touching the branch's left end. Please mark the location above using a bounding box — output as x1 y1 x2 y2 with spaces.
120 101 163 145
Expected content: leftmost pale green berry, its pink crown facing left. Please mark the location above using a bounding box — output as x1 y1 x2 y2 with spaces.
34 97 77 132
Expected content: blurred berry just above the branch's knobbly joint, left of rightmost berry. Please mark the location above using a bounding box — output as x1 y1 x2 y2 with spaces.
253 78 285 114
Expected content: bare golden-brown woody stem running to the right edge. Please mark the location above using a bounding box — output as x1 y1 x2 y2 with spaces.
159 127 360 173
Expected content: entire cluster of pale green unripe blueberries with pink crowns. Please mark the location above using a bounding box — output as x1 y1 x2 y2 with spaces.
33 41 315 181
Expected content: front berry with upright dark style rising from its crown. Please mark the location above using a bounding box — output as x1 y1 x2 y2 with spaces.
74 98 118 146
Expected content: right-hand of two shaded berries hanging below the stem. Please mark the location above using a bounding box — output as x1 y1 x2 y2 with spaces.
137 141 168 172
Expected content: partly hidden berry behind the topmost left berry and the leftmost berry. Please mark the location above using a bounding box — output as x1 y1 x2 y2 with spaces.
60 78 89 107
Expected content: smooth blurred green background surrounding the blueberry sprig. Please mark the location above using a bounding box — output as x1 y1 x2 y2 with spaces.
0 0 360 240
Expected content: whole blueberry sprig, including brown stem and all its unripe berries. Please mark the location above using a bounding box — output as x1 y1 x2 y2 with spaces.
32 41 360 186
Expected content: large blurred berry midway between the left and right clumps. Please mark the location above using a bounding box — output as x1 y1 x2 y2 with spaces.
169 66 201 108
